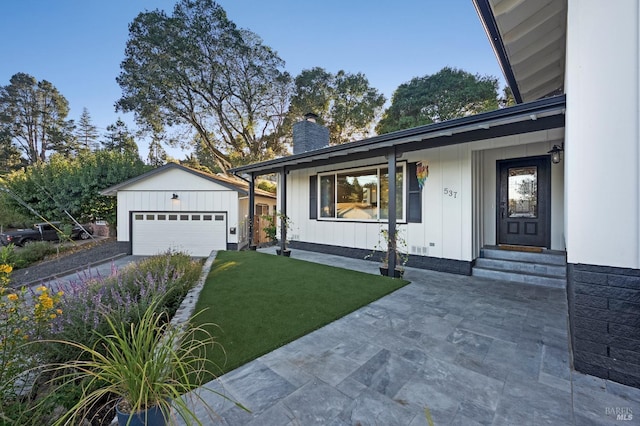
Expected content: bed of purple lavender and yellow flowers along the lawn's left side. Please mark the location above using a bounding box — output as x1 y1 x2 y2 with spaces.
0 250 202 426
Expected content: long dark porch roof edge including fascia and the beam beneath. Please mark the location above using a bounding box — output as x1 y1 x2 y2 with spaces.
230 95 566 175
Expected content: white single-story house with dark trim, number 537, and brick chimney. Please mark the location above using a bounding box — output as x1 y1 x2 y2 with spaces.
233 0 640 386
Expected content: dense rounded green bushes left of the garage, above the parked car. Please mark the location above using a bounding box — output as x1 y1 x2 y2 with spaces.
0 150 150 228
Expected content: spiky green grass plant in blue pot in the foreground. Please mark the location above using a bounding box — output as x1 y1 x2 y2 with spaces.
47 301 246 426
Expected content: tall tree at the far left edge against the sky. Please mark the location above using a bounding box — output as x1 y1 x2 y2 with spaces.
0 73 77 164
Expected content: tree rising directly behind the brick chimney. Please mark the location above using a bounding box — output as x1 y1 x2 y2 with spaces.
288 67 386 145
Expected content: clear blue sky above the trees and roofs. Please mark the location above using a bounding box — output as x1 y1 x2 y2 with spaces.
0 0 504 158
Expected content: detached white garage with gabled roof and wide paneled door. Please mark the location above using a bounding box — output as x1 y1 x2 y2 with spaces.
101 163 275 256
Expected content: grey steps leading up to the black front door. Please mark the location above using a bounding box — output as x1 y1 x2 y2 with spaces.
472 248 567 288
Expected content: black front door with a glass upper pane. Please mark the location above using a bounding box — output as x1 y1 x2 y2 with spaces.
497 156 551 248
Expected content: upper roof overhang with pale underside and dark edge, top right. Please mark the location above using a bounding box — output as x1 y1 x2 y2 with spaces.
473 0 567 103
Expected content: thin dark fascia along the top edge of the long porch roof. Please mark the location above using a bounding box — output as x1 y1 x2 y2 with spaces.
229 95 566 175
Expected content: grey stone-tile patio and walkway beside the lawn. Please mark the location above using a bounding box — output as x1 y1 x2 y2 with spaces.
178 249 640 426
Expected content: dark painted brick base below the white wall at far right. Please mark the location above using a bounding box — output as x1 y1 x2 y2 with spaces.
567 264 640 387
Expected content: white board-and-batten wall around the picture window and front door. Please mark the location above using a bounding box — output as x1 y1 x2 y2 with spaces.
287 129 564 261
